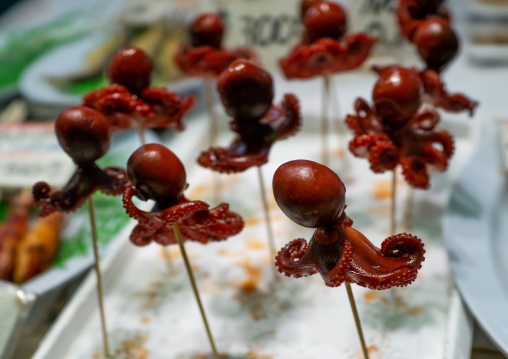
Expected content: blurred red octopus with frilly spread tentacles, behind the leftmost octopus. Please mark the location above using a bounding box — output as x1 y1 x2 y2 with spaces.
83 47 195 131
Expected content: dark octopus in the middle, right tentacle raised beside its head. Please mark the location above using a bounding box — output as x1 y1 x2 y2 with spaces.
198 60 300 173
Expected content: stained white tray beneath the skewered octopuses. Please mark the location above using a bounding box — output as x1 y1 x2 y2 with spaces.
34 88 472 359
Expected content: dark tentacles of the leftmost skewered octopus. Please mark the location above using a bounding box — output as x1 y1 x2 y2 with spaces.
32 167 130 216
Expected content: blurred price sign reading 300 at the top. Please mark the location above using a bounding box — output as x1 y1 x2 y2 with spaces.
217 0 302 71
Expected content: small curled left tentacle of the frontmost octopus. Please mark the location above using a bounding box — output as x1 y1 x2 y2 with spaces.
275 238 317 278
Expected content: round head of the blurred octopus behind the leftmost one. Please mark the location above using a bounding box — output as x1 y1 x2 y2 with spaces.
108 47 154 95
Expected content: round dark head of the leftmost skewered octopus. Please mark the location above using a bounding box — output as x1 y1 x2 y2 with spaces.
55 106 111 165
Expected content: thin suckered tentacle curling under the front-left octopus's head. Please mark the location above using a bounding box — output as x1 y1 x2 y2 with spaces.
123 187 208 227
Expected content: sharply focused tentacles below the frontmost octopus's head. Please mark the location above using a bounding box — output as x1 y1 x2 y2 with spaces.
275 217 425 290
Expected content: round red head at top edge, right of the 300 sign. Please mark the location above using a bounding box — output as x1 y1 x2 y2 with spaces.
302 1 347 43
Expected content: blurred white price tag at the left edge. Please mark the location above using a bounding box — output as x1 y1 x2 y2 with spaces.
0 123 75 188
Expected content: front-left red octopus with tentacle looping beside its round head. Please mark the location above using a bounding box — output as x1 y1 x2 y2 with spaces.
123 144 243 246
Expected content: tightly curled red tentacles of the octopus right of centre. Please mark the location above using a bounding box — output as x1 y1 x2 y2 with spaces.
346 99 454 189
